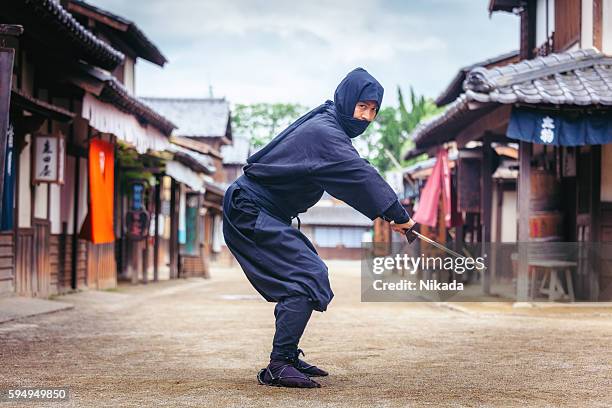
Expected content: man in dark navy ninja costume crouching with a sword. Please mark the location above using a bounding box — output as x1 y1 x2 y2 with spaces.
223 68 414 388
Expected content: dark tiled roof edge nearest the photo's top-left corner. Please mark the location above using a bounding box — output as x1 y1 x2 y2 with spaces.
0 0 124 70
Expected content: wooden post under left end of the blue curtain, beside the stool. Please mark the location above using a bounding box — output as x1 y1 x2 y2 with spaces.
516 142 533 302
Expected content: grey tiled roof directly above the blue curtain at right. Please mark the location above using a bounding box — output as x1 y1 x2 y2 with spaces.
411 49 612 148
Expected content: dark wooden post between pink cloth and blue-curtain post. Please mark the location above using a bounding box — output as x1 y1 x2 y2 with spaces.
480 134 493 295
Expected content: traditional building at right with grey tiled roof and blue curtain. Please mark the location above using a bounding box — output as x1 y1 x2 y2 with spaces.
408 0 612 300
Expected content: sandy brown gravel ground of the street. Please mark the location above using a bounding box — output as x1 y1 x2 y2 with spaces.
0 262 612 407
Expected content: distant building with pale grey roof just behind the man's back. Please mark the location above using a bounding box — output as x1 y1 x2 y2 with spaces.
143 98 233 276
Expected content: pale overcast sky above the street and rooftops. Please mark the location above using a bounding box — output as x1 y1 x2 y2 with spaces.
88 0 519 106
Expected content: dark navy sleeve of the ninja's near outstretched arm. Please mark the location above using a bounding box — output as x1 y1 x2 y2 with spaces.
309 131 405 220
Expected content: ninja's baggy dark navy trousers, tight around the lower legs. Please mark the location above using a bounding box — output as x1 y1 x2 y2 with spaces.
223 183 333 359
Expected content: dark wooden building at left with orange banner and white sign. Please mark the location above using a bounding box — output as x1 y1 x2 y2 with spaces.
0 0 174 296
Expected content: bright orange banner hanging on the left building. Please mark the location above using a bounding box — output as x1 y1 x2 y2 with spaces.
89 139 115 244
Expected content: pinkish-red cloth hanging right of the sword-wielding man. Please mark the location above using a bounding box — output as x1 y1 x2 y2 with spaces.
412 149 462 227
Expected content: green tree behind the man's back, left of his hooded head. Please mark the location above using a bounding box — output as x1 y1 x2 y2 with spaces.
232 103 307 148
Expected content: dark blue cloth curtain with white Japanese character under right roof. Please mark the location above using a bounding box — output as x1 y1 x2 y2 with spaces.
506 108 612 146
